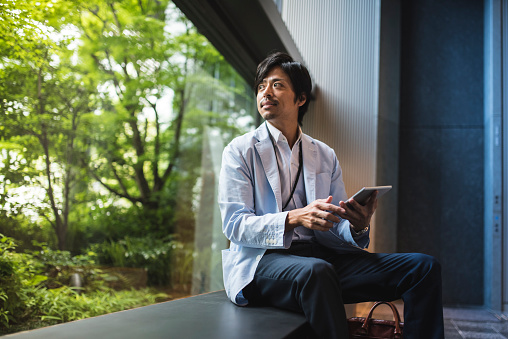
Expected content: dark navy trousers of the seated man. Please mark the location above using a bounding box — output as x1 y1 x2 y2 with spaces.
243 243 444 339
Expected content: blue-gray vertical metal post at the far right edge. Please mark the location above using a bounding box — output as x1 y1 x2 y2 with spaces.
484 0 508 311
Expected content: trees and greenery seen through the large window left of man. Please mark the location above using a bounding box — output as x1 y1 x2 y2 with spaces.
0 0 255 334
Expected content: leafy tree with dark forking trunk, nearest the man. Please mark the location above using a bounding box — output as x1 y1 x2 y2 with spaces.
79 0 244 230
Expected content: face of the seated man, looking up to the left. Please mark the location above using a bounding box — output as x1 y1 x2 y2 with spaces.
257 67 305 122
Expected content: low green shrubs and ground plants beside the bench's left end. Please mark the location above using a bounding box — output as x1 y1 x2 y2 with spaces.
0 235 168 335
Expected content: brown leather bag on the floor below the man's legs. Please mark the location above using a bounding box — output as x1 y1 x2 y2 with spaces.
348 301 404 339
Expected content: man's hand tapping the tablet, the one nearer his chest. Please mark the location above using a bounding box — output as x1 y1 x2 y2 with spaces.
286 196 343 231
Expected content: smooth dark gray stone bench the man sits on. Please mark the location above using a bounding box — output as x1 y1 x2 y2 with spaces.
3 291 310 339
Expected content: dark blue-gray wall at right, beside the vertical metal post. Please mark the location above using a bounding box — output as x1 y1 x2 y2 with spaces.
398 0 484 305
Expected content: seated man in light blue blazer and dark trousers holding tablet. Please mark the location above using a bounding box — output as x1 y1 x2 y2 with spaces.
219 53 444 339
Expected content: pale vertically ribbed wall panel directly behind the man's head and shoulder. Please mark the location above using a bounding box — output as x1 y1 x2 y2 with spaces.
281 0 388 250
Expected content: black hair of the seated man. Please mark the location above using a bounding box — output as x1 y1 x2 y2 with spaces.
254 52 312 125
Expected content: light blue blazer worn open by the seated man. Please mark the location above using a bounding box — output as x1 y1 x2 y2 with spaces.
219 124 369 305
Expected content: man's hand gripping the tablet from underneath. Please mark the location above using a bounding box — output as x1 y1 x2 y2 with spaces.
337 191 378 232
